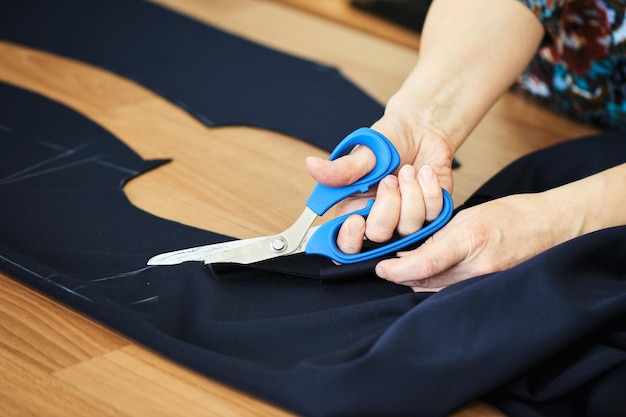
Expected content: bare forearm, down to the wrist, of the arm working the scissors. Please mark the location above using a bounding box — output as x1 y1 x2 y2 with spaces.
386 0 543 149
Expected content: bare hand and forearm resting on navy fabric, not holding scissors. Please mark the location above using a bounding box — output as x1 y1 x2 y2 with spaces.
376 164 626 291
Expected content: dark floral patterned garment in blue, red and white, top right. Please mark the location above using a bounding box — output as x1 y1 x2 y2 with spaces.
514 0 626 129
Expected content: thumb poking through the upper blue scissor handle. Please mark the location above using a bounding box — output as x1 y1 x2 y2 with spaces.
306 146 376 187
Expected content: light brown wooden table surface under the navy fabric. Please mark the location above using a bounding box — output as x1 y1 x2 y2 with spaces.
0 0 593 416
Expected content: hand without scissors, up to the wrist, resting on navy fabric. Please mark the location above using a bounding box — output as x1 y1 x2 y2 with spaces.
376 194 572 291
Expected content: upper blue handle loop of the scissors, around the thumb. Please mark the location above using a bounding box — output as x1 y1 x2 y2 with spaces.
306 127 400 216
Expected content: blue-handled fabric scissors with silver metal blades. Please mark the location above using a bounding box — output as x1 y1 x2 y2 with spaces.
148 128 453 265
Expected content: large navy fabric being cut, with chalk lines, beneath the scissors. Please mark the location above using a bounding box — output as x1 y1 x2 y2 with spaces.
0 84 626 417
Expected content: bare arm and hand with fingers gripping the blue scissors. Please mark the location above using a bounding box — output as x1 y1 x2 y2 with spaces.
307 0 543 253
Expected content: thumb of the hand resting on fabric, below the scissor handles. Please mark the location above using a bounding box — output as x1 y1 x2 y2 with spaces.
376 229 469 288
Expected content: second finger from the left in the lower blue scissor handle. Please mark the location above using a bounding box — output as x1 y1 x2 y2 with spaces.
365 175 401 242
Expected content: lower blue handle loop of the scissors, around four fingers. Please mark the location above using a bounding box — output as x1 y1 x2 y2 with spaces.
305 189 454 264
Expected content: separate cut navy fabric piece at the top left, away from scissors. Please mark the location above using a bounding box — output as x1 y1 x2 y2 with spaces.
0 0 383 150
